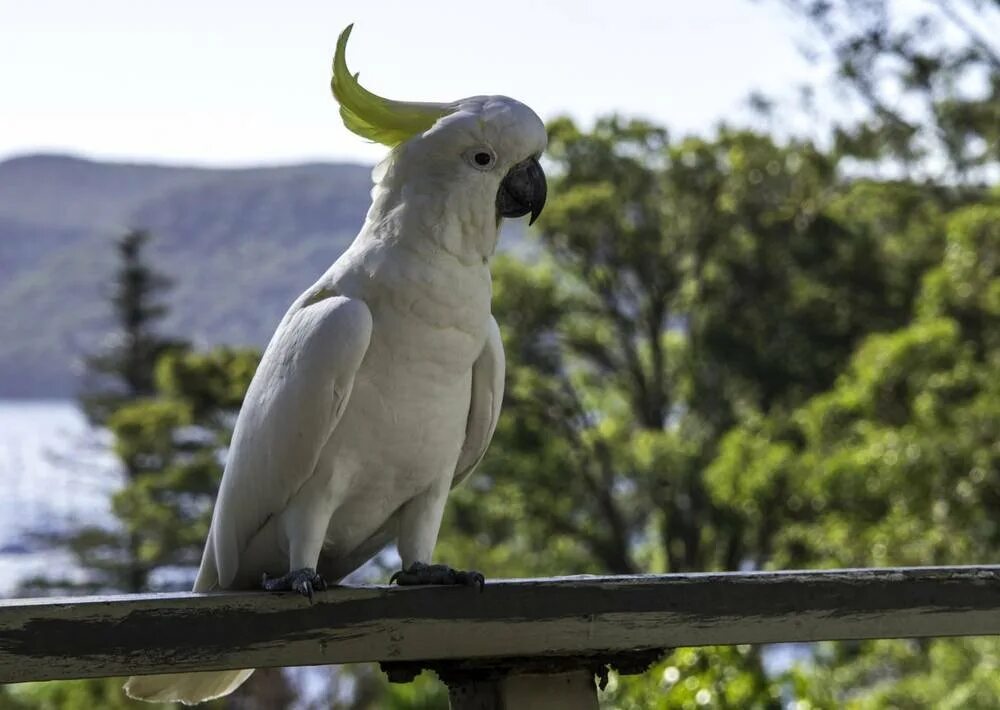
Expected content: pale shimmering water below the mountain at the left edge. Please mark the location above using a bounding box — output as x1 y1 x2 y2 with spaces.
0 400 121 596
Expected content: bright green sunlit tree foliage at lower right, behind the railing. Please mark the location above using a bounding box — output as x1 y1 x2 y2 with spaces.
706 205 1000 708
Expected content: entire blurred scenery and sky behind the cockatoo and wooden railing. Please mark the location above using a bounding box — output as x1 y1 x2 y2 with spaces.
0 0 1000 710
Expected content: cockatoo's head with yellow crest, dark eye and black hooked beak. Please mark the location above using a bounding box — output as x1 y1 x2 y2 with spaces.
331 26 546 229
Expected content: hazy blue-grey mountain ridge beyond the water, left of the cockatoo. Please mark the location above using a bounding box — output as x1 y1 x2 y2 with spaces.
0 155 519 398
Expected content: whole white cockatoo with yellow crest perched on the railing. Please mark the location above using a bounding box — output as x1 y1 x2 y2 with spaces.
125 27 546 703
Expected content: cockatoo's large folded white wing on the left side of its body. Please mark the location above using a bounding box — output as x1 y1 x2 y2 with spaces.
203 290 372 588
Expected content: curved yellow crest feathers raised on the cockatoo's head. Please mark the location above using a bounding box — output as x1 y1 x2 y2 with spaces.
330 24 450 148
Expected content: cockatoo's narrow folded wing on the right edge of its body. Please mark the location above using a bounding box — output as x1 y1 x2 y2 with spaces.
451 317 506 487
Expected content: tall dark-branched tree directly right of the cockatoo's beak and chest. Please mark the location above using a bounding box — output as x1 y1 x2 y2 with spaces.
448 119 938 573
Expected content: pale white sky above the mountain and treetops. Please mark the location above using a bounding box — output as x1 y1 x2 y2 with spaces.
0 0 818 166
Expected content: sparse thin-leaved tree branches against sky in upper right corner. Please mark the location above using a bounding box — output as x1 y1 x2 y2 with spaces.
783 0 1000 183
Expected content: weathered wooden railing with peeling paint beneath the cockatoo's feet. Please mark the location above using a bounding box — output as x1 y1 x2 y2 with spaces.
0 566 1000 683
